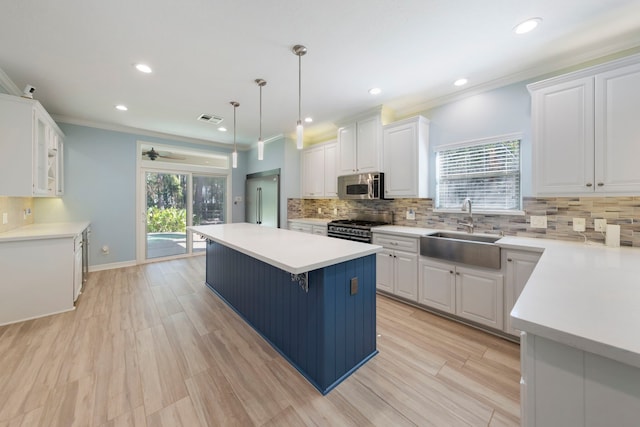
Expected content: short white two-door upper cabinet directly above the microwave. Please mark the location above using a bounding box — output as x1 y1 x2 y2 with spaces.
337 114 382 176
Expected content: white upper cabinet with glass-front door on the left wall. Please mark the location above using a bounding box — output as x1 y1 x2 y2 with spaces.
0 94 63 197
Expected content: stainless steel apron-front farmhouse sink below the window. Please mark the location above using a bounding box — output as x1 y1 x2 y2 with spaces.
420 232 501 269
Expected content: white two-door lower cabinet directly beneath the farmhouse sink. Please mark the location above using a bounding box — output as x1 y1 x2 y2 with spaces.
419 257 504 329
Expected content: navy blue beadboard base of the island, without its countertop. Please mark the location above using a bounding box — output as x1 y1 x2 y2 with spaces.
206 240 378 394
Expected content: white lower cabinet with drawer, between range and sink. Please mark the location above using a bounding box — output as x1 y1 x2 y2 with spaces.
372 234 419 301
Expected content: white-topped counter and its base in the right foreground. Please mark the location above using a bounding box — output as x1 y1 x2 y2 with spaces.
508 237 640 427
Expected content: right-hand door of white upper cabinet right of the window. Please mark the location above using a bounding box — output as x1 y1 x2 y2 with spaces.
595 64 640 194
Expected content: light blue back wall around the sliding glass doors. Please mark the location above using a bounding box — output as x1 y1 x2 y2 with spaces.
34 123 240 266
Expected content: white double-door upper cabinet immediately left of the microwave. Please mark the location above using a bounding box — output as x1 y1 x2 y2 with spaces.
302 141 338 197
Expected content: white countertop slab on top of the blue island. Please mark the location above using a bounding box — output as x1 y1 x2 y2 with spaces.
188 223 382 274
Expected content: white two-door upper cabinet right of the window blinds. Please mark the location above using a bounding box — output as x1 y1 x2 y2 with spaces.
528 55 640 195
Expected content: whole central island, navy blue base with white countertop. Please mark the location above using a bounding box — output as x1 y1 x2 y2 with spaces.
189 223 382 394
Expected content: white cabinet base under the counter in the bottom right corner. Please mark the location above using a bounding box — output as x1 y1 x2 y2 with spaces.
520 332 640 427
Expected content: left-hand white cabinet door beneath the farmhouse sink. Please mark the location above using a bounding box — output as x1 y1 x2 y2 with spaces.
419 258 456 314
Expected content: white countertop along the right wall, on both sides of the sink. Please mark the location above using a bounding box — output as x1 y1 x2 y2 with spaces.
374 226 640 367
